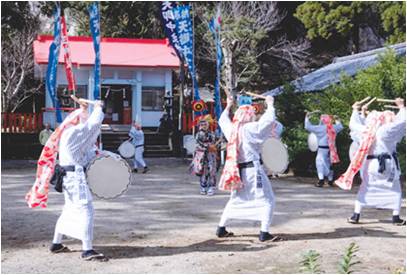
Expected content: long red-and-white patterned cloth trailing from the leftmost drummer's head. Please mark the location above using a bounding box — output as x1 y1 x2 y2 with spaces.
25 109 88 208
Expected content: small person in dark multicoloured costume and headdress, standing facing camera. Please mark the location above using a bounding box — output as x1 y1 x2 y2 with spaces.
190 115 217 196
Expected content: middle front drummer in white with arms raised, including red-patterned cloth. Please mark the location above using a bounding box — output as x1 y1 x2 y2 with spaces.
216 96 276 241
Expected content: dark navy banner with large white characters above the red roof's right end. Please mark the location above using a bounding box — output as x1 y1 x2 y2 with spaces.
161 1 184 61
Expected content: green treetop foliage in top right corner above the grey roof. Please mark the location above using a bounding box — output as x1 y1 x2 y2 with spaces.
294 1 406 52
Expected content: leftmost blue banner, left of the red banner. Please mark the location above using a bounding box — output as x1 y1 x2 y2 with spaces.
45 5 62 123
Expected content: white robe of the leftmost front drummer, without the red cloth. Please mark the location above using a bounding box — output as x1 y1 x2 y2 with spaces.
54 107 104 250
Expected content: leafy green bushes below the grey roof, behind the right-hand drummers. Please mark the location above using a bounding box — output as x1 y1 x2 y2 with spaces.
284 50 406 175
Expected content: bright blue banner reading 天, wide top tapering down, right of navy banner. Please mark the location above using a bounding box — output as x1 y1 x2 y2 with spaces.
172 5 201 100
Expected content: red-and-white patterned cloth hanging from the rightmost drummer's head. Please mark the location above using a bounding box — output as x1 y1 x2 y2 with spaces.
335 111 395 190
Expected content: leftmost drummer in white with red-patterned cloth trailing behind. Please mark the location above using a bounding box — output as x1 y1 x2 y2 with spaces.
26 98 107 261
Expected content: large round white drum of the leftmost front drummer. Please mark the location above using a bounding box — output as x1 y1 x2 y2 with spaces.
86 151 131 199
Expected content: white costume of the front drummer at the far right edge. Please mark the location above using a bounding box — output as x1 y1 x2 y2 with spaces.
349 108 406 212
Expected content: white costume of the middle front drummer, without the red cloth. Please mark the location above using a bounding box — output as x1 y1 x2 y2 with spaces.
219 107 275 232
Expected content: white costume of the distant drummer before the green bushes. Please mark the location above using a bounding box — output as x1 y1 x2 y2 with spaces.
305 116 343 181
